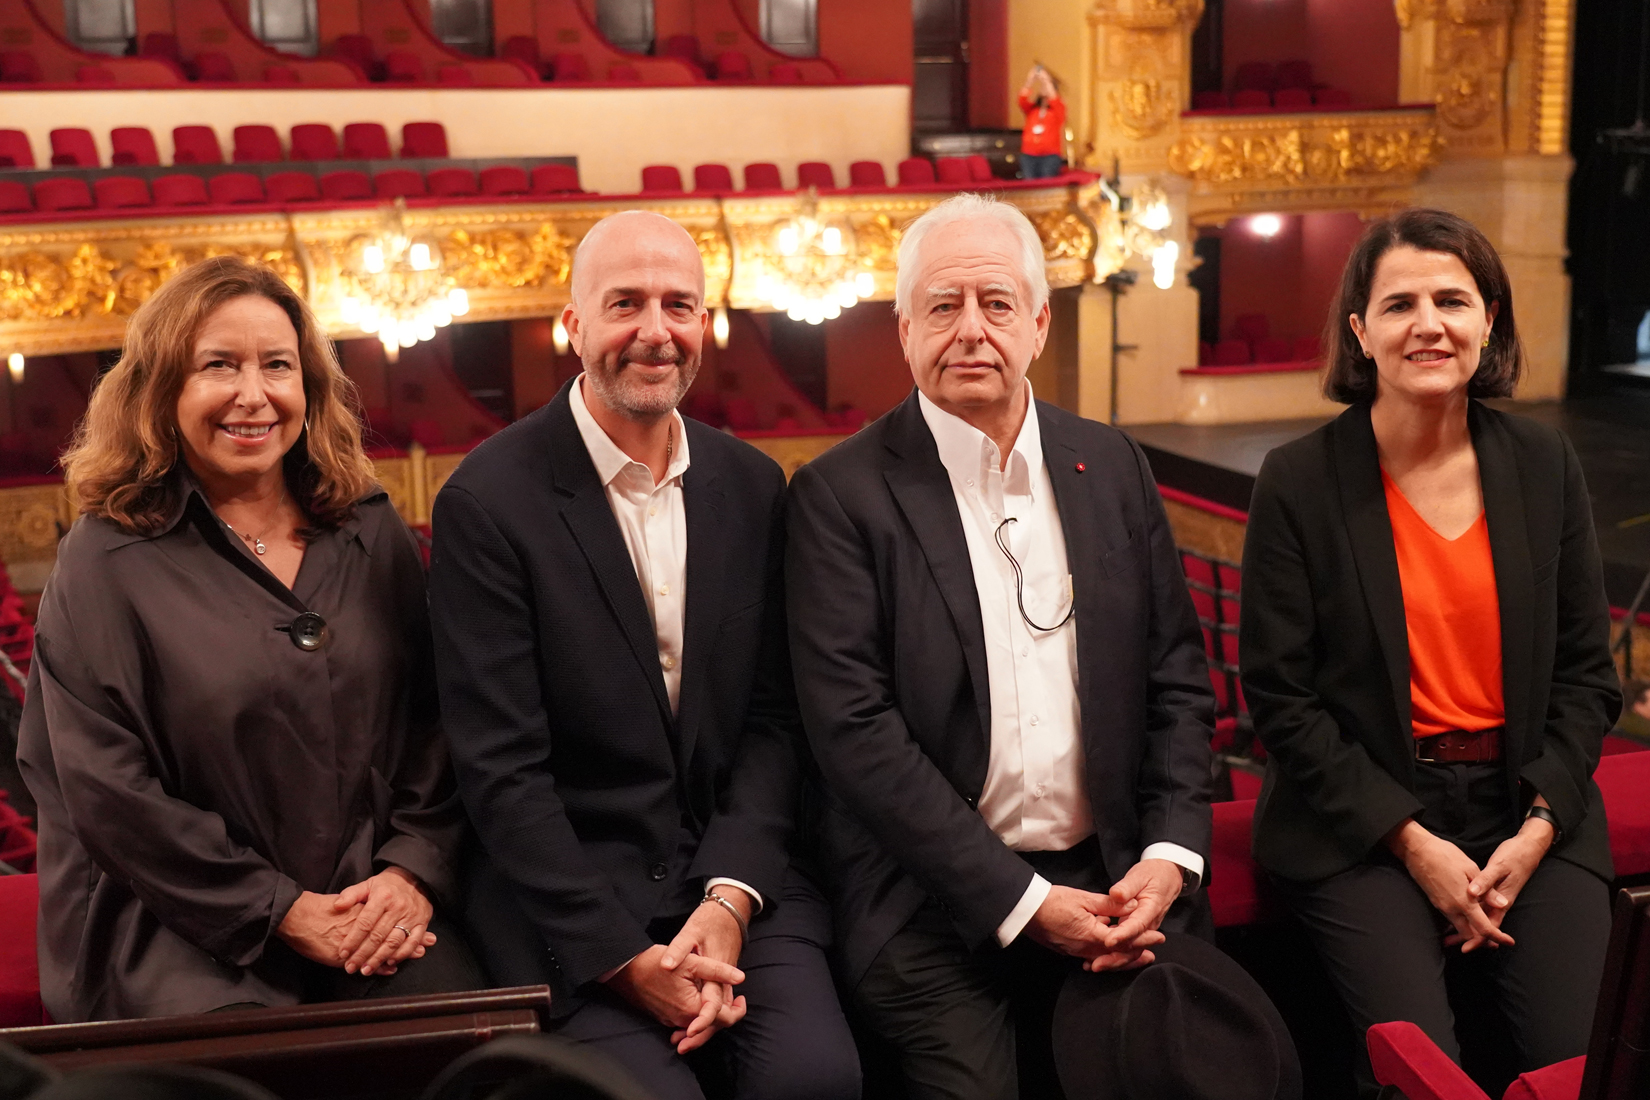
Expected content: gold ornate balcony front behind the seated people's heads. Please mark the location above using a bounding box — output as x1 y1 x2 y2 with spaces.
0 183 1122 356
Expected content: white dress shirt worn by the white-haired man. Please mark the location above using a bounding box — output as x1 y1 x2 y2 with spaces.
917 381 1203 947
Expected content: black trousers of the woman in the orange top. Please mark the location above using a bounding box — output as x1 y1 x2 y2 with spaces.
1275 764 1610 1097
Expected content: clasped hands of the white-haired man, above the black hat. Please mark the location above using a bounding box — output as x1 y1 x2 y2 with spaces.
1025 859 1183 973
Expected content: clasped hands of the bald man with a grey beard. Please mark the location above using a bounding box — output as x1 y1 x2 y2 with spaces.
607 887 752 1054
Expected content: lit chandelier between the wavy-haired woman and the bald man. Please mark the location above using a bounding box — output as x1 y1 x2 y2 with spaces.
340 198 470 363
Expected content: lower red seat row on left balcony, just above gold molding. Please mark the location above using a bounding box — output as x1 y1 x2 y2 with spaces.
0 165 579 214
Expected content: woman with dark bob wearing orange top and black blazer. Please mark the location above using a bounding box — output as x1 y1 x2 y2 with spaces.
1239 209 1620 1097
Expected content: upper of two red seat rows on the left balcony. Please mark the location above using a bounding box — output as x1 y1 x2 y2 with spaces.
0 122 447 168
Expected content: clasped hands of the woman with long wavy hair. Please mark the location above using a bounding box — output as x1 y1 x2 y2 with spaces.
276 867 436 978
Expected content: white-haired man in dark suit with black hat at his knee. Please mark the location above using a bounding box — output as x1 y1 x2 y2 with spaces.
785 195 1300 1100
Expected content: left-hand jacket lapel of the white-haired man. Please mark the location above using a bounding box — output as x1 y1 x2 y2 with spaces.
883 389 992 739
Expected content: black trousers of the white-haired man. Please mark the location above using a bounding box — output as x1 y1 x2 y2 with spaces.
853 838 1240 1100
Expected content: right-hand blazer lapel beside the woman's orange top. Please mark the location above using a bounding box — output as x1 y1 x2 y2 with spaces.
1467 401 1535 782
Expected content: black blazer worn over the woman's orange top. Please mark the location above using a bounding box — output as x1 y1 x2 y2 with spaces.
1238 401 1620 882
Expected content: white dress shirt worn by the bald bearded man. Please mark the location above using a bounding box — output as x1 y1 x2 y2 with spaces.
569 374 762 910
